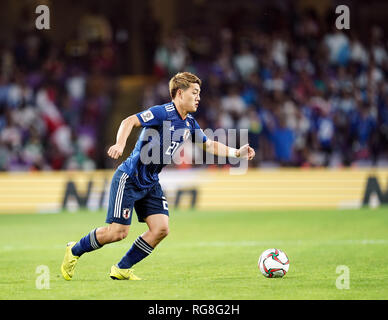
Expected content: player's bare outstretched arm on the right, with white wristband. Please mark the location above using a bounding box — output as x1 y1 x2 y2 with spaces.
203 139 255 160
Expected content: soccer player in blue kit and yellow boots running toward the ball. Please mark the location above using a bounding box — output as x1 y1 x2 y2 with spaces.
61 72 255 280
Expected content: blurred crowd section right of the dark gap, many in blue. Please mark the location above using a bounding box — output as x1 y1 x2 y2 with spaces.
143 12 388 167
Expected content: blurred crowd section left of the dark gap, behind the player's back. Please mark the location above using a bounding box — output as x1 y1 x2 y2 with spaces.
0 17 114 171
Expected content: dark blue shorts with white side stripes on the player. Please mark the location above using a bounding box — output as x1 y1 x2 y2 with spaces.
105 170 168 225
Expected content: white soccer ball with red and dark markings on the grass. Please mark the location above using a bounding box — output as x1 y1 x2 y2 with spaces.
258 248 290 278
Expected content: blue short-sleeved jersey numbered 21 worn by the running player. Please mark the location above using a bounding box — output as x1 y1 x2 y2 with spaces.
118 102 207 188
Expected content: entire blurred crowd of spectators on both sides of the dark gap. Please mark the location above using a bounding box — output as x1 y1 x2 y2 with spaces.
0 5 388 171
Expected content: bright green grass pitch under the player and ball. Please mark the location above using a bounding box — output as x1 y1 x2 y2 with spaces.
0 208 388 300
